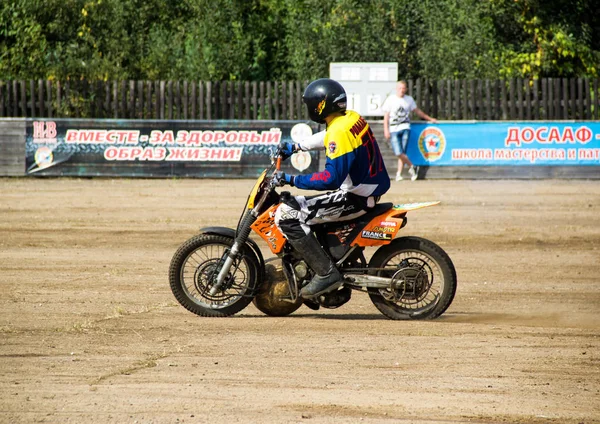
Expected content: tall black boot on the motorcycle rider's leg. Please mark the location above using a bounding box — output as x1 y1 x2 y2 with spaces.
289 234 343 299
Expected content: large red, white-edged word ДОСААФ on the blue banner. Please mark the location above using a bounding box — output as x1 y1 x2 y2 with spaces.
504 126 597 147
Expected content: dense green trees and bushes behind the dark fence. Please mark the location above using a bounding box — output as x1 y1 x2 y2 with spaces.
0 0 600 81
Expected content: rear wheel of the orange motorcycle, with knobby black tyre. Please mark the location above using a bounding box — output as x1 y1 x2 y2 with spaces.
368 237 457 320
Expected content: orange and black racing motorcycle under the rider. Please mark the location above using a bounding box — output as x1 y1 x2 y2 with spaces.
169 150 457 320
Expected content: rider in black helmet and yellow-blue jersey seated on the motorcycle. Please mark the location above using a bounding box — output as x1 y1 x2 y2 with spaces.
275 78 390 299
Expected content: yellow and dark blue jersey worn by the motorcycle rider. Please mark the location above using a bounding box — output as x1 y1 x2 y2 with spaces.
294 110 390 197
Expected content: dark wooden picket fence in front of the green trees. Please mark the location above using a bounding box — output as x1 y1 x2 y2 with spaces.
0 78 600 120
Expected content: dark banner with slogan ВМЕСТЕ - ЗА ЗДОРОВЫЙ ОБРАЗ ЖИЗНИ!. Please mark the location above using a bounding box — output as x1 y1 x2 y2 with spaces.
25 119 319 178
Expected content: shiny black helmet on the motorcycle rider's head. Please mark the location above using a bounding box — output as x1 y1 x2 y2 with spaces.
302 78 346 124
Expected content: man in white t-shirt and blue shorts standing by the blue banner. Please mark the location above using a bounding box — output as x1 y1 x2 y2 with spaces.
381 81 437 181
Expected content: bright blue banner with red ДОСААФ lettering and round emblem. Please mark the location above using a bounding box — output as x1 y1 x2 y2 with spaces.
407 121 600 166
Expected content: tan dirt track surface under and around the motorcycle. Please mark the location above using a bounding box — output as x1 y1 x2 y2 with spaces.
0 178 600 424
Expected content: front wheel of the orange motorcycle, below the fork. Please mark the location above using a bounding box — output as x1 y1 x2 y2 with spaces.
169 234 260 317
